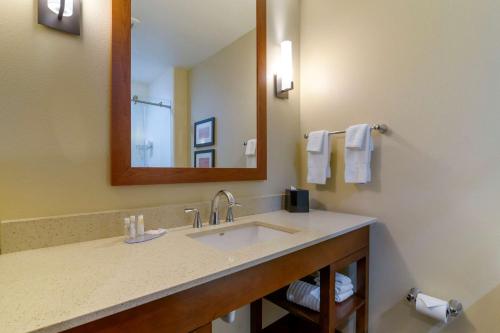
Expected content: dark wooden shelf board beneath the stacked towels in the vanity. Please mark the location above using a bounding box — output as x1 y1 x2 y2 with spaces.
265 287 365 326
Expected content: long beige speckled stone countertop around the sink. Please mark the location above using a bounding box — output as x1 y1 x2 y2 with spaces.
0 211 376 333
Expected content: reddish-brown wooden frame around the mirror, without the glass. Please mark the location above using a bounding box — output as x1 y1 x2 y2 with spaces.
111 0 267 186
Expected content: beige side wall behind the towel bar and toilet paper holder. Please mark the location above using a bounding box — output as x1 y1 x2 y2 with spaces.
300 0 500 332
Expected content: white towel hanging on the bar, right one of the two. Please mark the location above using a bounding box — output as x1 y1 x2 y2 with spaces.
344 124 373 184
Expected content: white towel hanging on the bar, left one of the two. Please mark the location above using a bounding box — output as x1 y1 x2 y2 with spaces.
307 131 331 184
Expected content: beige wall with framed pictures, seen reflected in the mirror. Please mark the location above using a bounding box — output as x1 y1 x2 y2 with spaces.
189 29 257 168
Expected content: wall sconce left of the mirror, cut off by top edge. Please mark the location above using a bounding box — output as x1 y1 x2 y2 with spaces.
38 0 80 35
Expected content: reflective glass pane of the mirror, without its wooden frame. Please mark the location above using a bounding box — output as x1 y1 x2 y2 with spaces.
130 0 257 168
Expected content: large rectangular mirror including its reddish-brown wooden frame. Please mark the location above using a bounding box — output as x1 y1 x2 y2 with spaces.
111 0 267 186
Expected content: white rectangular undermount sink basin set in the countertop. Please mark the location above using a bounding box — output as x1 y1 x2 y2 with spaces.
188 222 298 251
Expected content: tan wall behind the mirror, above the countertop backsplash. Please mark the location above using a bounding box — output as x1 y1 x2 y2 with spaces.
0 0 299 223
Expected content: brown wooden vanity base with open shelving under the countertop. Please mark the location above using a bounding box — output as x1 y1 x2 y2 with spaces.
67 226 370 333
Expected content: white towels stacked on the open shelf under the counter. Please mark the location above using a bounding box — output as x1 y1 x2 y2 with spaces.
286 273 354 311
